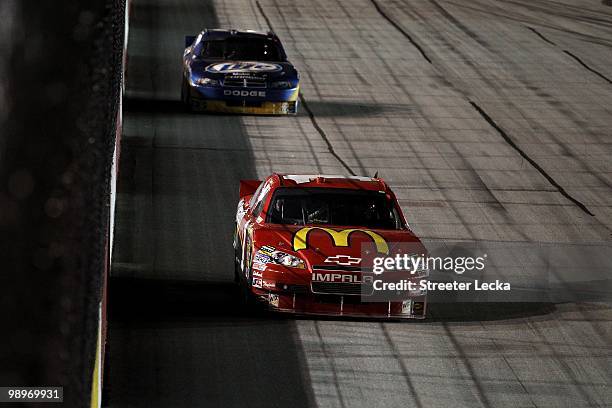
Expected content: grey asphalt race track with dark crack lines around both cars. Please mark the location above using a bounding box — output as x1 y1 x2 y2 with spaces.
105 0 612 408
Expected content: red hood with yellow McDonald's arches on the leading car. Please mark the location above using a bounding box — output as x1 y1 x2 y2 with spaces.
253 225 425 269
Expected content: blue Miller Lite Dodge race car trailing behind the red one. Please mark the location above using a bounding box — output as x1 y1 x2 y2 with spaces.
181 30 300 115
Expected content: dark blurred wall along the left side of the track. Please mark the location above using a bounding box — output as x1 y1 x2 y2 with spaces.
0 0 124 406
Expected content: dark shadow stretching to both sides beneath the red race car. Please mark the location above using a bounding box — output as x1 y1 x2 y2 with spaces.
110 277 555 324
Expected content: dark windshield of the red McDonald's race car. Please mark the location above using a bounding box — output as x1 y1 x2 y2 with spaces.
267 188 402 229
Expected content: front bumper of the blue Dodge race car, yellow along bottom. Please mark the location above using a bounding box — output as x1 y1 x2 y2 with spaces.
189 86 299 115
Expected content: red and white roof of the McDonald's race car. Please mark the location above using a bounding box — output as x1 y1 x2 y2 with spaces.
278 174 387 191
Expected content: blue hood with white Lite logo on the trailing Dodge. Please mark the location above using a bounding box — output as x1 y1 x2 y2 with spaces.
190 59 297 81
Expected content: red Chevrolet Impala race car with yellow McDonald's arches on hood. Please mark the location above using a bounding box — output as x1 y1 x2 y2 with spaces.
234 174 427 319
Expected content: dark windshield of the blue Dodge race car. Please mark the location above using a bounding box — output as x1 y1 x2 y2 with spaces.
200 38 282 61
